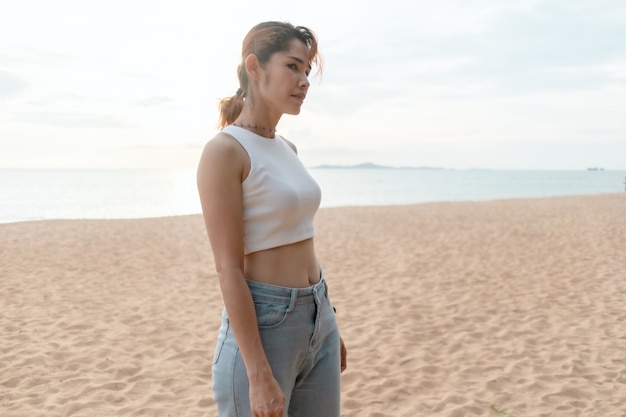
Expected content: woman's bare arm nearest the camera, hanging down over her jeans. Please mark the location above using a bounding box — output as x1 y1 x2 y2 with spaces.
197 134 285 417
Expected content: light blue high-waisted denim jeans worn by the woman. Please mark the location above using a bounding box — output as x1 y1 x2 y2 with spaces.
213 276 341 417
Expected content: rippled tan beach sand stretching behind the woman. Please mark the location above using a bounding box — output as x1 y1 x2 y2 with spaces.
0 194 626 417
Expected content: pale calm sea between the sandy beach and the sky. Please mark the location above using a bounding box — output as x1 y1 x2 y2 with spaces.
0 166 626 223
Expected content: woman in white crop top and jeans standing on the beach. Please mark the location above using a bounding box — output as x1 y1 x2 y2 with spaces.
198 22 346 417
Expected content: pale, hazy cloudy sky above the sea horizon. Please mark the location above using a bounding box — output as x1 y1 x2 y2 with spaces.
0 0 626 170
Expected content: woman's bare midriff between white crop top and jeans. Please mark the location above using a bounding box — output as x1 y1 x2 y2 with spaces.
244 238 320 288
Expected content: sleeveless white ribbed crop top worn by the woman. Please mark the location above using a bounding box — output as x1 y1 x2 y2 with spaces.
222 125 321 255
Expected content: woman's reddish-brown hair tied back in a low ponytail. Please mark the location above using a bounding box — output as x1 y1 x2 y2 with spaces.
218 22 322 128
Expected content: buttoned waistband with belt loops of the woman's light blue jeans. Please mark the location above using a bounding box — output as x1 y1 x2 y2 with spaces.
246 273 328 305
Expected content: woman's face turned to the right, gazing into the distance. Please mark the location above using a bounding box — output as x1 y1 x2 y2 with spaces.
259 39 311 114
